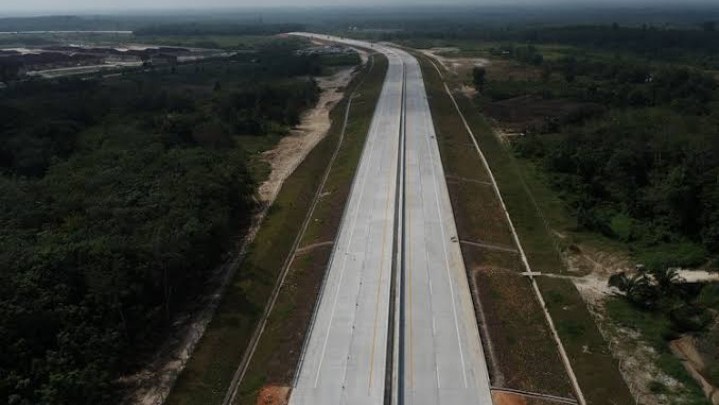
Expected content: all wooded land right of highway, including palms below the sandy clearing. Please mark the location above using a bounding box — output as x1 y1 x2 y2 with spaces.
466 23 719 392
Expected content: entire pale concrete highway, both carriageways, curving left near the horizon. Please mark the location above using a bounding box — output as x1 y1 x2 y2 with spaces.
290 34 492 405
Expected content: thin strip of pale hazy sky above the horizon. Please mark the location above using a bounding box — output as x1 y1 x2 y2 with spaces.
0 0 717 14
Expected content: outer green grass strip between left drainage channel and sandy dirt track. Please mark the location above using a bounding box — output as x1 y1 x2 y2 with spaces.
166 55 384 404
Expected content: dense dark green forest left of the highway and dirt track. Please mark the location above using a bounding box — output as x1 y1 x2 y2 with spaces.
0 42 322 404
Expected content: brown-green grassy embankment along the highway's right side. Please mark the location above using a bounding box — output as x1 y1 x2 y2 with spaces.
416 52 633 404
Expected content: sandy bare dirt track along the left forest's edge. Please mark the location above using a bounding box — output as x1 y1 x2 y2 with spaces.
119 61 367 405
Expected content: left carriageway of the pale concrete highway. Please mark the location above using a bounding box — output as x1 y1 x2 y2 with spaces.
290 36 403 405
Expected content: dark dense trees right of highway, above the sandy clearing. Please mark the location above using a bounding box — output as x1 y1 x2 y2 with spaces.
485 47 719 268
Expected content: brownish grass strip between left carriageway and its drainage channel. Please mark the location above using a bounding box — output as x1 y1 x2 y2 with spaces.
235 55 387 404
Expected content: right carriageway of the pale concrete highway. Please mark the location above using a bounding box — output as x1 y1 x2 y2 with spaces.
398 51 491 404
